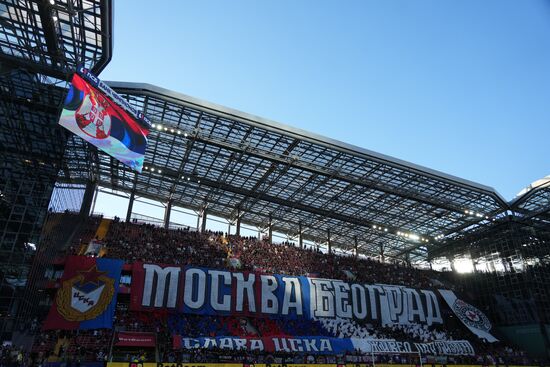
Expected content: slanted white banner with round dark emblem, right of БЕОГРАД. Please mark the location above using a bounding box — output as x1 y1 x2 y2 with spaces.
439 289 498 343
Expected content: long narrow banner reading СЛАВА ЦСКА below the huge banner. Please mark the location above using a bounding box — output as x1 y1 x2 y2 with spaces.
173 335 475 356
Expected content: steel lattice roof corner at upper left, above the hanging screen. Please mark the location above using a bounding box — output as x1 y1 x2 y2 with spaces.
0 0 113 80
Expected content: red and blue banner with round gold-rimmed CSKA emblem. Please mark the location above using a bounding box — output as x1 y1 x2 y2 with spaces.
44 256 124 330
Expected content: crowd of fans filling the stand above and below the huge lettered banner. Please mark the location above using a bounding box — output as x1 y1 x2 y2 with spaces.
22 220 548 364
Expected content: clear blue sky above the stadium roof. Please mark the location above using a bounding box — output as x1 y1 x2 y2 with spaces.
101 0 550 200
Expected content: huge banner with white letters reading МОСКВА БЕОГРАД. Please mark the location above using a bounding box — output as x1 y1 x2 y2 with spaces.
131 263 443 325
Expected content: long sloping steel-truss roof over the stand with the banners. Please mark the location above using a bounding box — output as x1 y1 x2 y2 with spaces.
64 82 508 259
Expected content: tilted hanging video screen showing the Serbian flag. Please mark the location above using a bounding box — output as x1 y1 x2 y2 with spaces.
59 69 150 172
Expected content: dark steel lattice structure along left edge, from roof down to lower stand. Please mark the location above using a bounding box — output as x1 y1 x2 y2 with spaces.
0 0 112 340
